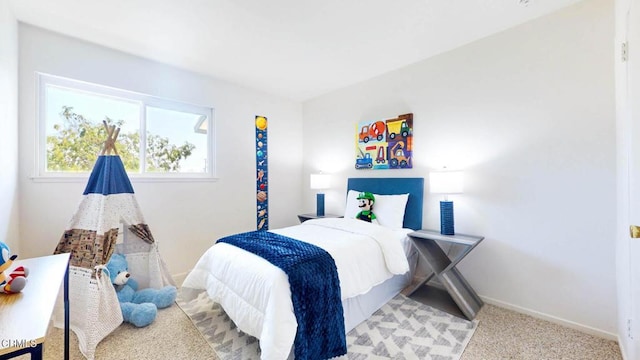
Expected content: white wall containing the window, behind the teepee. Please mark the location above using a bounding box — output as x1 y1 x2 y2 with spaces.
19 24 302 274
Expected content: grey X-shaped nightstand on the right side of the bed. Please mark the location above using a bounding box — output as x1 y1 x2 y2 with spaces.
402 230 484 320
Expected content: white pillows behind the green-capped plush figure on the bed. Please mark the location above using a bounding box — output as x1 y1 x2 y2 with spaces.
344 190 409 229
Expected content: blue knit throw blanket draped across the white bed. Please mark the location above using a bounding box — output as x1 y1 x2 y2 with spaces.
218 231 347 360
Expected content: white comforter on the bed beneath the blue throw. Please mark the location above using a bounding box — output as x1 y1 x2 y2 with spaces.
182 218 410 360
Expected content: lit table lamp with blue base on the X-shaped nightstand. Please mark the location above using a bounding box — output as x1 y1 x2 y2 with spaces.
429 171 464 235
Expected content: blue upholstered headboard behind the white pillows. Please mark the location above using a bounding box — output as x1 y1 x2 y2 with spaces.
347 178 424 230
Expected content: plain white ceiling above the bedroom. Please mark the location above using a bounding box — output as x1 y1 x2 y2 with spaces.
10 0 581 101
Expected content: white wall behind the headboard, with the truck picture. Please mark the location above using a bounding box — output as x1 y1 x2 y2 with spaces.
303 0 617 338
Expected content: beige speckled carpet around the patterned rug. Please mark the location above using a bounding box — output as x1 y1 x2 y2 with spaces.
28 294 622 360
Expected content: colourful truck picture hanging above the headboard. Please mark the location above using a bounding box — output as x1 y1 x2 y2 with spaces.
355 114 413 169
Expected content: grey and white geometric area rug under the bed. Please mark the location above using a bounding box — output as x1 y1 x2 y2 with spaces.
177 292 478 360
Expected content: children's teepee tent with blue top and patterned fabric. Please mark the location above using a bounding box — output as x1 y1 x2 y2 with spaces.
54 122 175 360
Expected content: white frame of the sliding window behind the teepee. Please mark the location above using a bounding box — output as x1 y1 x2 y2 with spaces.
34 73 216 181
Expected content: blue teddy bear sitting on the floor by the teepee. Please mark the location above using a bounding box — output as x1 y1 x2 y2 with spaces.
107 253 178 327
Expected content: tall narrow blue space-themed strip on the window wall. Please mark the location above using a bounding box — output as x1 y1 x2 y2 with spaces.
256 116 269 230
